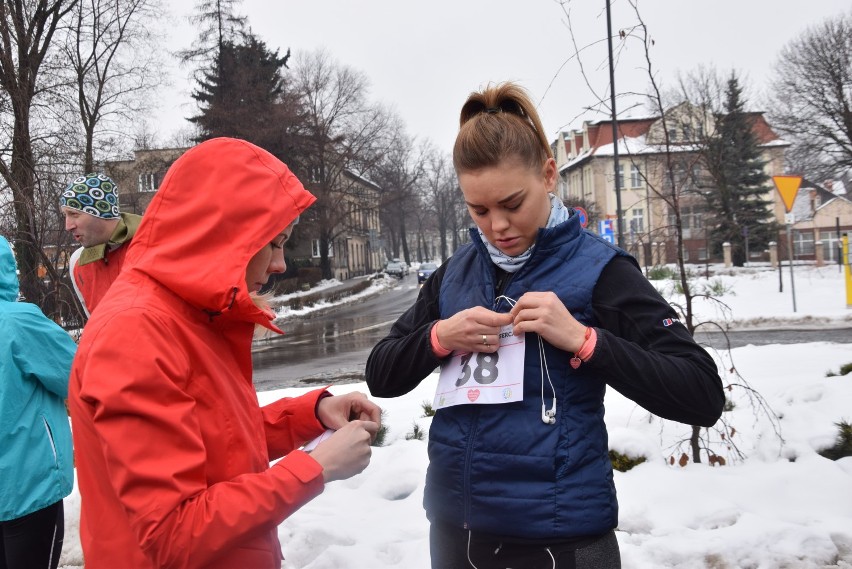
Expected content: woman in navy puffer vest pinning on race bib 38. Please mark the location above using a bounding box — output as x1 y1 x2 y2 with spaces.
366 83 725 569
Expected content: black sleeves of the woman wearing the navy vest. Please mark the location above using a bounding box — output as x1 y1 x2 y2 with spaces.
366 256 725 427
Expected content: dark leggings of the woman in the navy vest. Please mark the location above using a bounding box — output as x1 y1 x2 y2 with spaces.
429 524 621 569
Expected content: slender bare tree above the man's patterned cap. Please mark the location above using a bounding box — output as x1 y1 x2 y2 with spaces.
63 0 162 172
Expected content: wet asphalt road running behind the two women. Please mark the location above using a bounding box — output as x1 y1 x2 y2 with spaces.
252 273 852 391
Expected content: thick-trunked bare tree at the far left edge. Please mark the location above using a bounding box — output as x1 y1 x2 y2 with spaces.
0 0 76 312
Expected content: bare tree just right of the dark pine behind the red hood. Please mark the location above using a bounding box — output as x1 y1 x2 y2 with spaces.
291 51 402 278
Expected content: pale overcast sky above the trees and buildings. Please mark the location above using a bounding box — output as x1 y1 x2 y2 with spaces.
158 0 850 151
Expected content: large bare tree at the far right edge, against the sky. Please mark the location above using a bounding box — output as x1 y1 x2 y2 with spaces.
771 12 852 178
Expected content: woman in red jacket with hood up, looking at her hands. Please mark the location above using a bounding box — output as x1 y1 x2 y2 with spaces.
70 138 380 569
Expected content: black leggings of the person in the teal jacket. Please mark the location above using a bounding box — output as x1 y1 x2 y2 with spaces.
0 500 65 569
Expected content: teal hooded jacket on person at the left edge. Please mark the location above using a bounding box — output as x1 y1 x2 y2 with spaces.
0 237 77 521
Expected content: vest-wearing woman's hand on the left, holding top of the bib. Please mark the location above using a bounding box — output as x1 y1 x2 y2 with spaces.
435 306 512 353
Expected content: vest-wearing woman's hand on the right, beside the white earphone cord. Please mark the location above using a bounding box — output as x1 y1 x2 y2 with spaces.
509 292 586 353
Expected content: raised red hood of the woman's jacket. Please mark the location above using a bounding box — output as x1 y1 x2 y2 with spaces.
126 138 316 325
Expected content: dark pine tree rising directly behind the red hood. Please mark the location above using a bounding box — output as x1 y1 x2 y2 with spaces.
189 33 298 161
